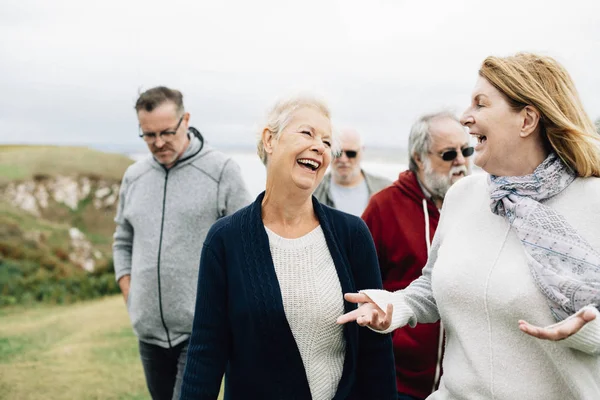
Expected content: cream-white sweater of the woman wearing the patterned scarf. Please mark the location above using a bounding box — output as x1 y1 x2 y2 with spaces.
364 175 600 400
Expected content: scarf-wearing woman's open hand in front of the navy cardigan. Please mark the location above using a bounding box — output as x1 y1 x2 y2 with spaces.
337 293 394 331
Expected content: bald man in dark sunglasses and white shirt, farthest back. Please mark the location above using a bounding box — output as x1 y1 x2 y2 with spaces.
314 129 392 217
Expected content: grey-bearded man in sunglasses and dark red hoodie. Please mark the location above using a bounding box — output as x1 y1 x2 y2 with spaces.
362 112 473 400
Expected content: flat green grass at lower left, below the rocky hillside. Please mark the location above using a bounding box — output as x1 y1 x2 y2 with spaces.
0 296 225 400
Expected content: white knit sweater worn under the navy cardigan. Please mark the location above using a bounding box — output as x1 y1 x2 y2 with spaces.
266 226 346 400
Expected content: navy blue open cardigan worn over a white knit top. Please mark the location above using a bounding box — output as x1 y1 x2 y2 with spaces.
181 192 398 400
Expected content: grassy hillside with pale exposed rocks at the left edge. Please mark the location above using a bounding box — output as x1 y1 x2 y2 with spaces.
0 145 132 306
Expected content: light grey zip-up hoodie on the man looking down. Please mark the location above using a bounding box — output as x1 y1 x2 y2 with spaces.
113 133 251 348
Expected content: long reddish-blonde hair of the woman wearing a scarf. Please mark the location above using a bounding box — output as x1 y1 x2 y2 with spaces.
479 53 600 177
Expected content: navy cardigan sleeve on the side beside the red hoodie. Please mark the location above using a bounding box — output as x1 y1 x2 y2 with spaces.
352 221 398 399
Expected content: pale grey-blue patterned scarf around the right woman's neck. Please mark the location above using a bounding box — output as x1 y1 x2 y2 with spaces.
489 153 600 321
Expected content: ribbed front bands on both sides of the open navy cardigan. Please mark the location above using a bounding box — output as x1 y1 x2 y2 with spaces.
242 192 358 399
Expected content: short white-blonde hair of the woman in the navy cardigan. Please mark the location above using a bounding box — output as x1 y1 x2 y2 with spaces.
256 94 340 165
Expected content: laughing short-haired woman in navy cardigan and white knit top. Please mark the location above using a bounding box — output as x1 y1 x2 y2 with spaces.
181 97 396 400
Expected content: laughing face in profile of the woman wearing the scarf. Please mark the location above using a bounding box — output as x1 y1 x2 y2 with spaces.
461 77 521 175
